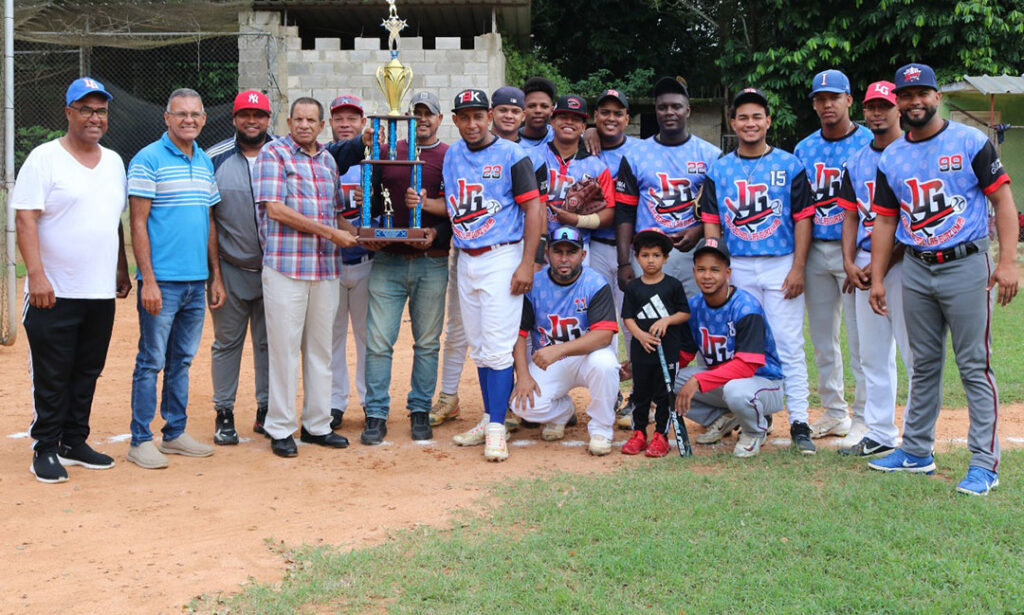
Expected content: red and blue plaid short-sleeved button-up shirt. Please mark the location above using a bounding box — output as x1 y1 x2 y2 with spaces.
253 135 341 280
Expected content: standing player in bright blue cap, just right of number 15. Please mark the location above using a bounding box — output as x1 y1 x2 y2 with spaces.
793 70 871 445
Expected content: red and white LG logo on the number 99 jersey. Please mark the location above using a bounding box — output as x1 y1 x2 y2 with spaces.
900 177 967 246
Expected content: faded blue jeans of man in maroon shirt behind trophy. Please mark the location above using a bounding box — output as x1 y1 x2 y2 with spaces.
366 252 447 419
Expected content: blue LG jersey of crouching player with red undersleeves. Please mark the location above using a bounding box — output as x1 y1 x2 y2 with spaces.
684 289 782 380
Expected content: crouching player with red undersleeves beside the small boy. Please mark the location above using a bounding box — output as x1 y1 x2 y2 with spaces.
676 237 783 457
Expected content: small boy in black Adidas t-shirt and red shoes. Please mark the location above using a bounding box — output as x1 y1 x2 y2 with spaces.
623 229 690 457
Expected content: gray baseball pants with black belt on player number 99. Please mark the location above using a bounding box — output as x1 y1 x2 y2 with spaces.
900 241 999 472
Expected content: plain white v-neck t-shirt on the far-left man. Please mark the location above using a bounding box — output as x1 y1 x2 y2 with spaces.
11 139 128 299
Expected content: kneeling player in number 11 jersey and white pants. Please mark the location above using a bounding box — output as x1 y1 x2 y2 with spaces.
512 226 618 455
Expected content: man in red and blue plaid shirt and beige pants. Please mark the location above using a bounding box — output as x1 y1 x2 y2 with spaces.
253 97 355 457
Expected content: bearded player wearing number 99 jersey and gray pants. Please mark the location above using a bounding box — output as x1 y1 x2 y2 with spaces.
868 63 1018 495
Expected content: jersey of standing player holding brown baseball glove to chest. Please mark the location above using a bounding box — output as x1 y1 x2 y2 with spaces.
528 141 615 241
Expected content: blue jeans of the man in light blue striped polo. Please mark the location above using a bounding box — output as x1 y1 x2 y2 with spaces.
131 280 206 446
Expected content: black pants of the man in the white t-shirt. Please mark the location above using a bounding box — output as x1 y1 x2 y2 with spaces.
24 298 114 452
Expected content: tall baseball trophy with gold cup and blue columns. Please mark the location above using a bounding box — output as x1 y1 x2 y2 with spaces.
358 0 426 243
